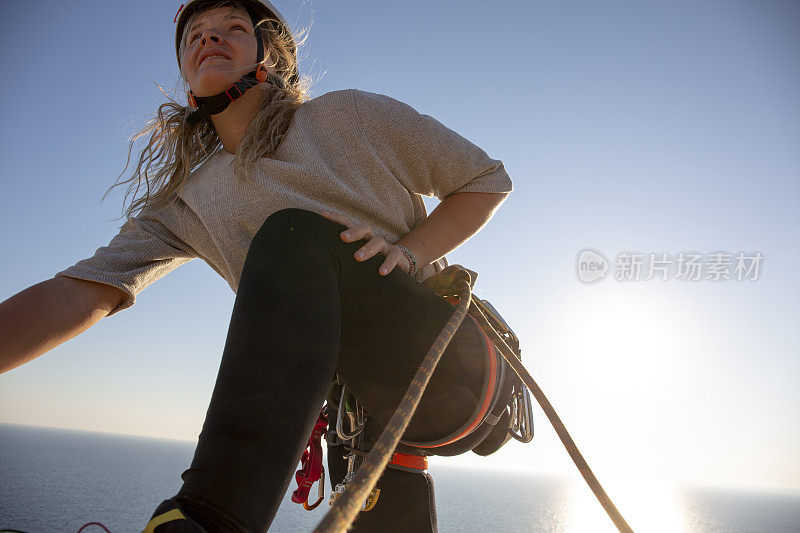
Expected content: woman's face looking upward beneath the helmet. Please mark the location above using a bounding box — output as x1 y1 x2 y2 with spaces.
181 6 272 96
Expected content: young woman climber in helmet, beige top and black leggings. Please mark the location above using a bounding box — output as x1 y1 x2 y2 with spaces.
0 0 512 533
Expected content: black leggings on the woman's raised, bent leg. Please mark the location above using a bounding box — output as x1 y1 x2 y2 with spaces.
170 209 494 532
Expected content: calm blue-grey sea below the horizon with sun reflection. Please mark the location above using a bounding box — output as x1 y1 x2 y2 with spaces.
0 424 800 533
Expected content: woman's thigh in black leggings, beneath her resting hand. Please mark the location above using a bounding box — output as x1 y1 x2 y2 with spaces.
324 226 486 442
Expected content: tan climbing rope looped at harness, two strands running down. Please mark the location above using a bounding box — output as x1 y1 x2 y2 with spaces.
314 265 633 533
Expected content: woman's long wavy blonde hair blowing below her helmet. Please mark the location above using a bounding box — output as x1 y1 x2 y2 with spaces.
101 0 312 220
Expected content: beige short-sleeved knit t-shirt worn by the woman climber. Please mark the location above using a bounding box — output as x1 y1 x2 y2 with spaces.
55 89 512 316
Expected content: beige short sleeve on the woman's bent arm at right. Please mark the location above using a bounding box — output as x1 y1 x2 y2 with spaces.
351 89 513 200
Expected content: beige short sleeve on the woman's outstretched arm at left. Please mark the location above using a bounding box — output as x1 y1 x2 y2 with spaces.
55 198 198 316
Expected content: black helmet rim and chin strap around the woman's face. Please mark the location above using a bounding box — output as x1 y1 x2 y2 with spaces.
173 0 300 124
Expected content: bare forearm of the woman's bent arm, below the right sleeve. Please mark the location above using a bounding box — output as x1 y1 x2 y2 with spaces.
394 192 508 268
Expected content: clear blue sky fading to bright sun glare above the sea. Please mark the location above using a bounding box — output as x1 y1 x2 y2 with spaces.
0 0 800 498
